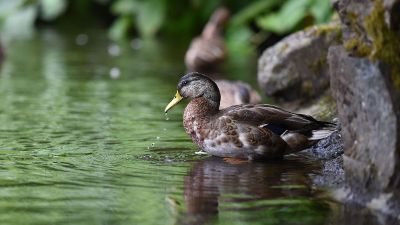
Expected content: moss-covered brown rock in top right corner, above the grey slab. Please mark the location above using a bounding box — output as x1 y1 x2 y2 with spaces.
336 0 400 74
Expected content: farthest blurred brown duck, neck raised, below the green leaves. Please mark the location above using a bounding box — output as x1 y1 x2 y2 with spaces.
185 8 229 72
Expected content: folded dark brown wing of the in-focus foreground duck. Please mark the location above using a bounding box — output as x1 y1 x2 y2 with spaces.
219 104 334 135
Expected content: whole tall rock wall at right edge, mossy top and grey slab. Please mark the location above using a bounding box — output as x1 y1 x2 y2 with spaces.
328 0 400 212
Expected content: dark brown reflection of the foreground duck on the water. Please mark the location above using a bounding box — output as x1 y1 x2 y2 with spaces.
181 157 324 224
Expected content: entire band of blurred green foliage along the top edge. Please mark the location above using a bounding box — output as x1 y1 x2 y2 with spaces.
0 0 332 44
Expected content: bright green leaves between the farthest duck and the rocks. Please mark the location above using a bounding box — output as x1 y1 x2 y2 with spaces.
227 0 332 52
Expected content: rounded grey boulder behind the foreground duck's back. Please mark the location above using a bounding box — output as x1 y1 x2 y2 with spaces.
258 23 341 100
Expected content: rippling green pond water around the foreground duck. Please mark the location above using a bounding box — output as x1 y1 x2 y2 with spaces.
0 30 332 224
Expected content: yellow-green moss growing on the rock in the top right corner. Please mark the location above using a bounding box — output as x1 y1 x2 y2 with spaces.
365 0 400 88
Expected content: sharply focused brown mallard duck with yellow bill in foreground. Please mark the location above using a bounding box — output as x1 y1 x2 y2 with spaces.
165 72 334 160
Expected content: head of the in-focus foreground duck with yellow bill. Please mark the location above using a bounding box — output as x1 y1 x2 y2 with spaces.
164 72 221 112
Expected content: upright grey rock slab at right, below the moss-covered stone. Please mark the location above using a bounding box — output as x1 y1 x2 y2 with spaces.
328 46 400 214
